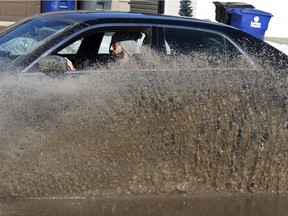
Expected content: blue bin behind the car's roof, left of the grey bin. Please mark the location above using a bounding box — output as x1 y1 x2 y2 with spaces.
41 0 75 13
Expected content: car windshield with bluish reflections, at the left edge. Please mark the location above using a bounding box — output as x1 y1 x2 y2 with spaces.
0 19 70 58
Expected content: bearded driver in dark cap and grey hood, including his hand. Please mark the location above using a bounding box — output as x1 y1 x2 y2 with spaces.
65 32 138 70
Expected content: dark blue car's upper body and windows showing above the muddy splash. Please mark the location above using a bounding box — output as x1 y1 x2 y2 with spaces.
0 11 288 73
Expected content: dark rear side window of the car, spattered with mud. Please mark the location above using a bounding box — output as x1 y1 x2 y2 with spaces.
164 28 251 67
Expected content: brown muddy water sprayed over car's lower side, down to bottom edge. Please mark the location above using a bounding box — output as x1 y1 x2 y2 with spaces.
0 60 288 215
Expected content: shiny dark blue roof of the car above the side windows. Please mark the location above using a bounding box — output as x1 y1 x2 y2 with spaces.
29 10 231 28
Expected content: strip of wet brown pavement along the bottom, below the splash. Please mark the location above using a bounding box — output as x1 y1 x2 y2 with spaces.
0 193 288 216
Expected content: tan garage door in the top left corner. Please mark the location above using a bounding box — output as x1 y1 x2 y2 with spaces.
0 0 41 21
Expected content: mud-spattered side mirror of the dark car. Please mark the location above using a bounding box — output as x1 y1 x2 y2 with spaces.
38 55 68 75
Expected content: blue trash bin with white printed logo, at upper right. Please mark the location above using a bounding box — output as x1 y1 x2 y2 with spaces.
228 8 273 40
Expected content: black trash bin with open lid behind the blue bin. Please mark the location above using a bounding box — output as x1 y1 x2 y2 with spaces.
213 2 255 25
